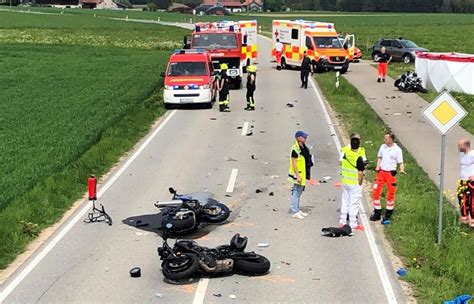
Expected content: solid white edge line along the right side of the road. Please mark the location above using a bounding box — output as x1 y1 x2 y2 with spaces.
310 77 397 304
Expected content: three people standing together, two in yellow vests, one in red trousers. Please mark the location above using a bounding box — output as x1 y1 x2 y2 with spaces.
288 131 405 230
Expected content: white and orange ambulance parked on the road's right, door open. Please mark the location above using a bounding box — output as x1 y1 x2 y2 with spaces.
272 20 355 73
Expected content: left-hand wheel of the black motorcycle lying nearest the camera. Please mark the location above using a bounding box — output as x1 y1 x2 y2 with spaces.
161 253 199 281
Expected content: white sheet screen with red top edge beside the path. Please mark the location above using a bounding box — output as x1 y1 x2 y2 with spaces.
415 52 474 94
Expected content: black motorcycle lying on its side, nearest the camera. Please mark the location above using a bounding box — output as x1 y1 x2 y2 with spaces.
158 234 270 281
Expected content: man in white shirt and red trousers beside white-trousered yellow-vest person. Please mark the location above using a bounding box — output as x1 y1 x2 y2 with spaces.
370 131 405 224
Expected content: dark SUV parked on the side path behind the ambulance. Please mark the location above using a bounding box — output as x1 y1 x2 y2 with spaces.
372 38 429 63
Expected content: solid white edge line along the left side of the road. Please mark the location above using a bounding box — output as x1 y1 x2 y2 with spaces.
0 110 176 303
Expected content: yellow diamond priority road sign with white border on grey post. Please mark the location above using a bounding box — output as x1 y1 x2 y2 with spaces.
423 92 467 134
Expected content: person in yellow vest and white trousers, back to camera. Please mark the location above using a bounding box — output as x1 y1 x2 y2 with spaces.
339 133 367 230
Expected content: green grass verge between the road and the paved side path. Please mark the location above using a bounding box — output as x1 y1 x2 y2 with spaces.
316 73 474 303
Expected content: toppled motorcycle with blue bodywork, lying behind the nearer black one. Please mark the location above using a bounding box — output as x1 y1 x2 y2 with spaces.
155 187 230 233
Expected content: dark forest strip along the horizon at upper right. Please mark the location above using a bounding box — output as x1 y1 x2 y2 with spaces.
264 0 474 13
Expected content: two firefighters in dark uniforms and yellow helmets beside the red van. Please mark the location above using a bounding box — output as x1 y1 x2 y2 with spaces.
216 63 257 112
